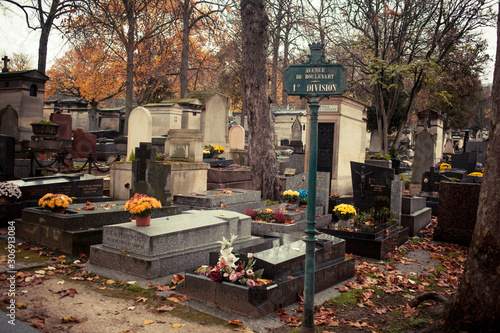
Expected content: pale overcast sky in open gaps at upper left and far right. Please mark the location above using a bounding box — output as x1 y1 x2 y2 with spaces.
0 5 497 83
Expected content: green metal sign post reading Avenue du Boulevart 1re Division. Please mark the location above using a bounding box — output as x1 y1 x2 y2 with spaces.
283 43 347 332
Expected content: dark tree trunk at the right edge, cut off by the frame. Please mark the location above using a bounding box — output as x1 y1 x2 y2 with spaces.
444 4 500 332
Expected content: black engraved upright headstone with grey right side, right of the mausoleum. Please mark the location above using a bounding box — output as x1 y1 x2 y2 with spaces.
351 161 403 220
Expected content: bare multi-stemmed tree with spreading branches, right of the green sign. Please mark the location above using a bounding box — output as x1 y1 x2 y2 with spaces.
339 0 494 153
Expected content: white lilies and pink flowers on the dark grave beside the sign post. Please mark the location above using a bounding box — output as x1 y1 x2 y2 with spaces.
194 235 268 288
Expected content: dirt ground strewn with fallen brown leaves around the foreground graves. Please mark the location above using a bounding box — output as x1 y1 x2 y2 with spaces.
0 218 466 333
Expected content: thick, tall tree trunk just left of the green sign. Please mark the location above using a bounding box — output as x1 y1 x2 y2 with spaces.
241 0 280 200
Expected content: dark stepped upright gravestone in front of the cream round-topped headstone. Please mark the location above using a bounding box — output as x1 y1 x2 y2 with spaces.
130 142 172 206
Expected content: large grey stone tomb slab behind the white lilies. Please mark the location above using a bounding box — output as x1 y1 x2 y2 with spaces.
90 211 256 279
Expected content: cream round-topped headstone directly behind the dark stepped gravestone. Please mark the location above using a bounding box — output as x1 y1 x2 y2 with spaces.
127 106 153 161
